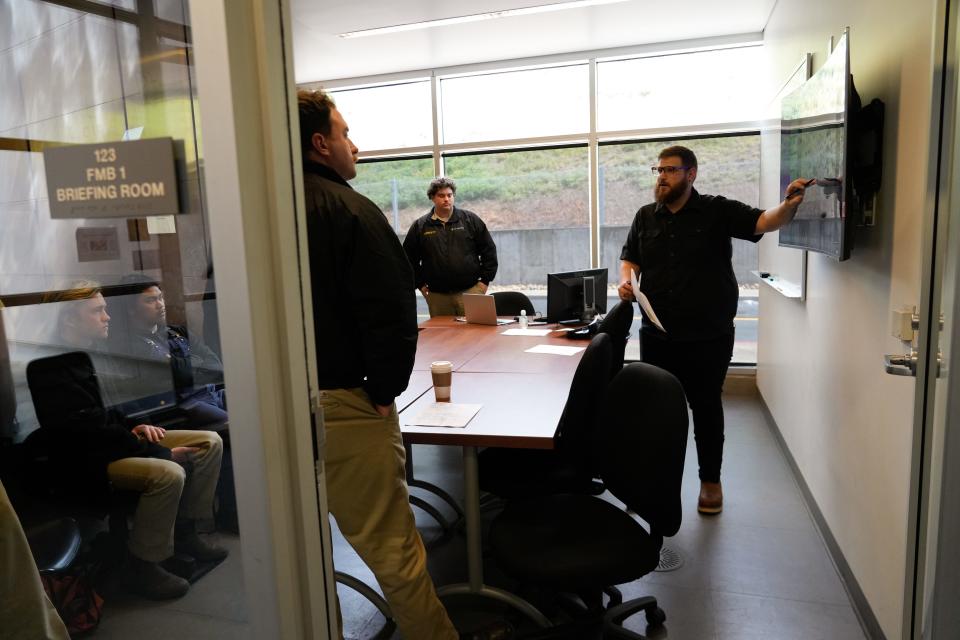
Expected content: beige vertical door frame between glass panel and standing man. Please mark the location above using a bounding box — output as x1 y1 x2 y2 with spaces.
190 0 337 640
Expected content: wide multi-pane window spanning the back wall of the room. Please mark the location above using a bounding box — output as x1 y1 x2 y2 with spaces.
316 44 772 362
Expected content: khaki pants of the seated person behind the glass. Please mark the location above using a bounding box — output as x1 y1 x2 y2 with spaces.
107 431 223 562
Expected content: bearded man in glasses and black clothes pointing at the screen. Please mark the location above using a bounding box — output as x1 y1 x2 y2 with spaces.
618 146 809 514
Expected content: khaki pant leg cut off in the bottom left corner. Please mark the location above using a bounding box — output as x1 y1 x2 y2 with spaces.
0 483 70 640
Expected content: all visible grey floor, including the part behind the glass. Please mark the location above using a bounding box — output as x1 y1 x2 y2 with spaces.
95 382 865 640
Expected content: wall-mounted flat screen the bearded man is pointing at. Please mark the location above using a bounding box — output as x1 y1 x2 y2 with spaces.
780 32 860 260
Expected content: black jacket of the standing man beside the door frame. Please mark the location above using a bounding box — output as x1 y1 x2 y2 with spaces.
303 162 417 405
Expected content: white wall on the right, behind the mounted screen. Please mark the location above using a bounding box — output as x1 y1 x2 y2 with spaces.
757 0 934 638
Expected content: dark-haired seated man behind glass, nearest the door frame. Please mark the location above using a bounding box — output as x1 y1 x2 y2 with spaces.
111 274 227 431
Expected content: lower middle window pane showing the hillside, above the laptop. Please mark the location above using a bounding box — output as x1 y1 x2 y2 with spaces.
445 146 590 288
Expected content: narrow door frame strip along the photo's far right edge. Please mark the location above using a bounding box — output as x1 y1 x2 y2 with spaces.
904 0 960 638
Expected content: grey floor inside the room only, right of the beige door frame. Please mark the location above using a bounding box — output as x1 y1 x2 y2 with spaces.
335 384 865 640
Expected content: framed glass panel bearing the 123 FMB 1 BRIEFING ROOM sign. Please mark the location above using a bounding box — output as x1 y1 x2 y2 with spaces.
0 0 333 638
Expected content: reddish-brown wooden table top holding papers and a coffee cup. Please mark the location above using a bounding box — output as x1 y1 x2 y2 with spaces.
397 318 588 449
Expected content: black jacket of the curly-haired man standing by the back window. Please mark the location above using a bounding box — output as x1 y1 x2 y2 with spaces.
403 207 497 293
